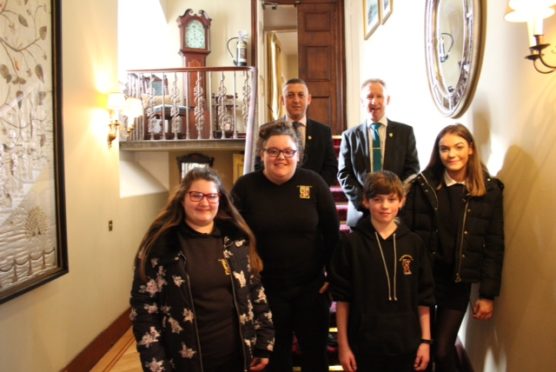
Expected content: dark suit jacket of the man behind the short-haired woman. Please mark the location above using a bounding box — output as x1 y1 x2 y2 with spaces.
255 119 338 185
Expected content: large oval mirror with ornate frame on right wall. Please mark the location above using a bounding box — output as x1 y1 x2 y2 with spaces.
425 0 484 118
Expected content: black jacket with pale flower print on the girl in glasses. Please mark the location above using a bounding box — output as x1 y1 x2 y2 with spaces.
130 222 274 372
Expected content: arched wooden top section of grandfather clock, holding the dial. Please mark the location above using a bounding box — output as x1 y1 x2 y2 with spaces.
178 9 212 67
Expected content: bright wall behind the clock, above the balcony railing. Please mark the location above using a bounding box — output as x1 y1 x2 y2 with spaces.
118 0 251 72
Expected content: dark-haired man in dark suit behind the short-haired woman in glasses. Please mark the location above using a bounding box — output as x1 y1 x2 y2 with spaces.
255 78 338 185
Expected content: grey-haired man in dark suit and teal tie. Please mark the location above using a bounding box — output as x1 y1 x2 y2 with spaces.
338 79 419 226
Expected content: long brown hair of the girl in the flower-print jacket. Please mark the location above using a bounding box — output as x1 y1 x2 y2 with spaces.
137 167 263 280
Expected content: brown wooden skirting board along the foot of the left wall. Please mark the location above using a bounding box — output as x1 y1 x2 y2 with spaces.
62 308 131 372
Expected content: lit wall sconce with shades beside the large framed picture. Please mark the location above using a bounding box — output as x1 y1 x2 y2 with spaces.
108 92 143 147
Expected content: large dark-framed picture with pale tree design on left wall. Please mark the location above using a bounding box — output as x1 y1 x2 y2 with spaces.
0 0 68 303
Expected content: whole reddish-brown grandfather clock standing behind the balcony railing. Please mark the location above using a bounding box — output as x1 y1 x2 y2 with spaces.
177 9 212 138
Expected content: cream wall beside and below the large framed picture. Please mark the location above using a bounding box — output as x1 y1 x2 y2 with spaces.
0 0 167 372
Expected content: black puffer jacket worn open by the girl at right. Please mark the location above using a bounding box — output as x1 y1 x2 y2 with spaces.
401 171 504 298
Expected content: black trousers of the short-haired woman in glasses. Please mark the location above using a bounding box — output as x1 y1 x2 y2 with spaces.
265 286 330 372
